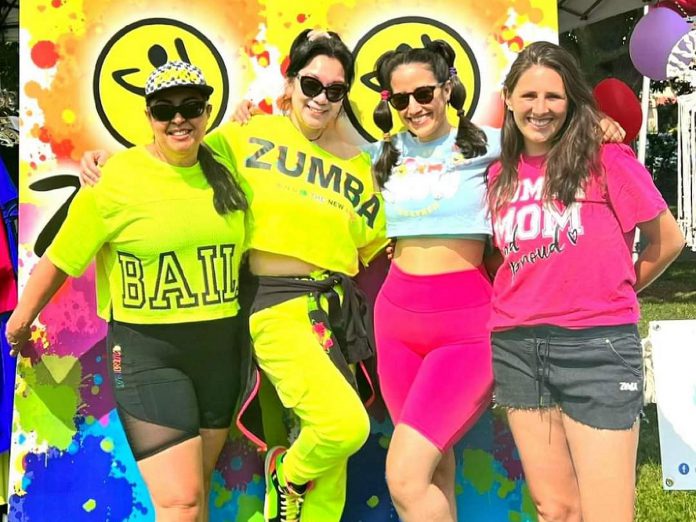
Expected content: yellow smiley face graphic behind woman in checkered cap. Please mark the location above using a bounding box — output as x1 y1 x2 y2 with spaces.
92 18 230 147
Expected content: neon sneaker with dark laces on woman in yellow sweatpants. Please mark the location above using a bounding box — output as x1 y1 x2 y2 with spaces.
263 446 307 522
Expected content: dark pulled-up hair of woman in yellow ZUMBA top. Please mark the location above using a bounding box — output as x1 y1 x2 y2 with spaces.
278 29 355 110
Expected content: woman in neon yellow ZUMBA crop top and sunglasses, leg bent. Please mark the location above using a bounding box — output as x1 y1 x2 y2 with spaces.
83 31 386 522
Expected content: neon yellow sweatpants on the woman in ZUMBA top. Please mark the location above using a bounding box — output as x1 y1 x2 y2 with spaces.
249 296 370 522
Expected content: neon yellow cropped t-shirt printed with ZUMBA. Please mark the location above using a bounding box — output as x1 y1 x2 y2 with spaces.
206 116 386 275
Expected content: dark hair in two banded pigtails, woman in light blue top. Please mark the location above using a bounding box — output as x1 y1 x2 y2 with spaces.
373 40 487 186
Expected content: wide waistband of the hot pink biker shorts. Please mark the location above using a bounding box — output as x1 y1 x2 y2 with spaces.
381 263 491 311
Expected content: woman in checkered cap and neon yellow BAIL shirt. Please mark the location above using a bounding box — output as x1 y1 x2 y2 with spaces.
6 62 247 522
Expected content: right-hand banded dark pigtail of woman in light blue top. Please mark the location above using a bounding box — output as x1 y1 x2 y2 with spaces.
425 40 488 158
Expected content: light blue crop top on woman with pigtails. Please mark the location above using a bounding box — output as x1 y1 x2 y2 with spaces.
367 127 500 239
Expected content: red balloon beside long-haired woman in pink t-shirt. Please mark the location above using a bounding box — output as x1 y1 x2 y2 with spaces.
593 78 643 143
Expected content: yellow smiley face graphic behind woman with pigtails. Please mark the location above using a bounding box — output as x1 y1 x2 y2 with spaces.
346 16 481 141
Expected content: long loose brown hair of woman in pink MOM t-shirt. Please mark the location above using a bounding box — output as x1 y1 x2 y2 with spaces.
488 42 601 212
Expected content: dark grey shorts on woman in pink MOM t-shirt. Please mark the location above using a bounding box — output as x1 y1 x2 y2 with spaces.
492 324 643 430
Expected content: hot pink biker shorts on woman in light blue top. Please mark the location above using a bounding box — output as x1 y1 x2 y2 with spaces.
375 263 493 451
